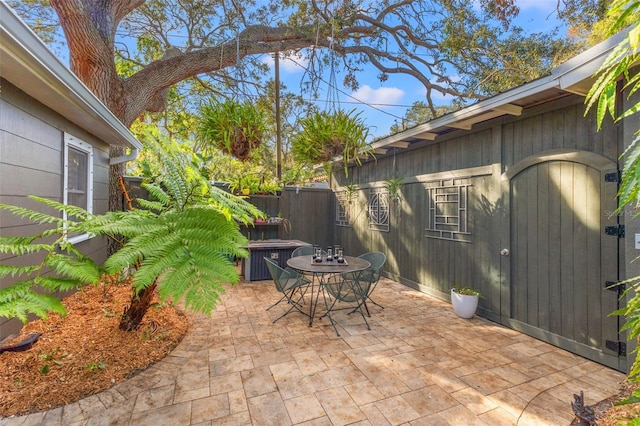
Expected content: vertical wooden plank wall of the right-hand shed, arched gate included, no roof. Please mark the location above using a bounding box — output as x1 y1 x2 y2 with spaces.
332 90 623 367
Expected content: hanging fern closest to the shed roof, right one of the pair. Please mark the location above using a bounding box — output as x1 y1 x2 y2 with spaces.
290 109 372 174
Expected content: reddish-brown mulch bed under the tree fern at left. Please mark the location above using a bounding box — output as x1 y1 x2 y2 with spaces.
0 283 188 418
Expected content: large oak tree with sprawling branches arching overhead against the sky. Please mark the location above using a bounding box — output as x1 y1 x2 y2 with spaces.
7 0 604 126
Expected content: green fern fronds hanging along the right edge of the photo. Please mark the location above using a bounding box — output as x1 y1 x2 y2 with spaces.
585 0 640 381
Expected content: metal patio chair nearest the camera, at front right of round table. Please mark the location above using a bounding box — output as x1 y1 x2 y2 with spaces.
322 268 374 337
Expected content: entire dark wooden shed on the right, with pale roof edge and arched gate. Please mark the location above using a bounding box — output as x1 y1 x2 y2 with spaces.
331 30 640 371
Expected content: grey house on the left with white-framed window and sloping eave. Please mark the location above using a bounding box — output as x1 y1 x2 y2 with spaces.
0 2 142 339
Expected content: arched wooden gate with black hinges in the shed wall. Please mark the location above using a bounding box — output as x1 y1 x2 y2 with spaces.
503 152 624 369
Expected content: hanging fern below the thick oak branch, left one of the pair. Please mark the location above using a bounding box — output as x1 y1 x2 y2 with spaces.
195 100 266 161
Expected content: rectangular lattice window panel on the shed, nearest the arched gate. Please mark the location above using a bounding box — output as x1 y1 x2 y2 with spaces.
425 180 471 242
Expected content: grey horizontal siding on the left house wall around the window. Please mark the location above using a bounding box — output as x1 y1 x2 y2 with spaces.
0 79 109 338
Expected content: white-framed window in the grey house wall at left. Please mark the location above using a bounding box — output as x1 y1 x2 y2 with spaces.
62 133 93 243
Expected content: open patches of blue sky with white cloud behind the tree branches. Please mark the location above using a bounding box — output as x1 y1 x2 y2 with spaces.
265 0 558 138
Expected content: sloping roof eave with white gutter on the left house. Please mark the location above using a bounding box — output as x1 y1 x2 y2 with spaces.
0 1 142 149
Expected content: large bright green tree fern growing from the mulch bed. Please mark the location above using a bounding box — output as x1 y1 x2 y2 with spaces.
91 136 262 313
